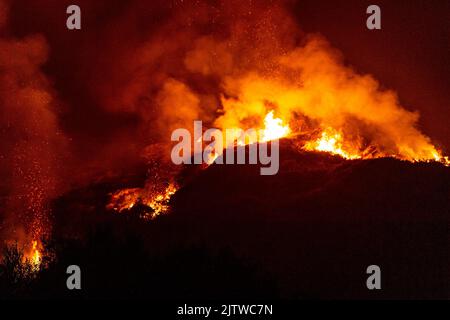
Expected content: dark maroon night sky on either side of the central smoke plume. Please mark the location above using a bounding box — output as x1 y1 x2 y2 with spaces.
6 0 450 153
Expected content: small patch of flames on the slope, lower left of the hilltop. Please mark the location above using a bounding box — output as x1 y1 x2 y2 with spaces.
106 183 177 220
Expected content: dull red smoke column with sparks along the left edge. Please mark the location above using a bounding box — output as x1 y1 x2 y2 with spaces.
0 1 65 249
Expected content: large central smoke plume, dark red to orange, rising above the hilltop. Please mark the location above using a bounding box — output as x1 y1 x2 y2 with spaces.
74 1 438 160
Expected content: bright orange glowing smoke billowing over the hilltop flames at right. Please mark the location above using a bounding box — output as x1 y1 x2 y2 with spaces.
215 36 448 164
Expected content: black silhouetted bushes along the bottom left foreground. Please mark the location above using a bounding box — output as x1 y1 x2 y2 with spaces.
0 228 275 299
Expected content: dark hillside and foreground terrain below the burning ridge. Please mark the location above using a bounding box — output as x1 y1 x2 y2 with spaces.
0 142 450 299
